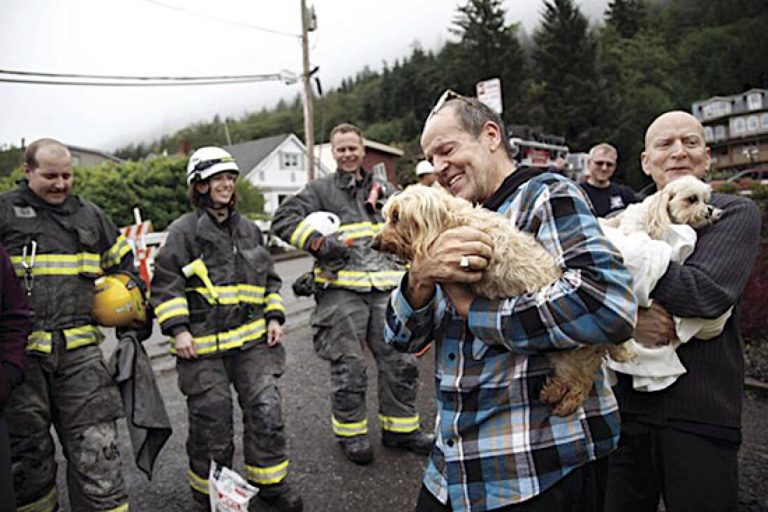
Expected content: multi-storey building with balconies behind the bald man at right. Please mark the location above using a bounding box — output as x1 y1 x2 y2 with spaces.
691 89 768 173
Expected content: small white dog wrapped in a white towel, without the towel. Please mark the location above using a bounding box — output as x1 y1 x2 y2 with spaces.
600 176 723 240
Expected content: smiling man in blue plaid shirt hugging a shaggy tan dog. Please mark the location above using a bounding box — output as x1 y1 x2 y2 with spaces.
385 92 637 512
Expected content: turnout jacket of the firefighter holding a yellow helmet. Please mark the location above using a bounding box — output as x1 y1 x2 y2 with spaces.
0 180 133 354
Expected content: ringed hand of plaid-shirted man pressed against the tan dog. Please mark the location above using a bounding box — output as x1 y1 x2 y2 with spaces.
405 227 493 315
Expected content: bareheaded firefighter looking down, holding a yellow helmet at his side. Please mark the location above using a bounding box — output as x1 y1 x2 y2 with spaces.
0 139 133 512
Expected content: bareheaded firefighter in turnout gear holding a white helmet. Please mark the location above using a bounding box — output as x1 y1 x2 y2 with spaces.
272 124 433 464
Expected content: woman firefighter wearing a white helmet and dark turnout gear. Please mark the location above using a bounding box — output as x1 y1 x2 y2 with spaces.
151 147 302 511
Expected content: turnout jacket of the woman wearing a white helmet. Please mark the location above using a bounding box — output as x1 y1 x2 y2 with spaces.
151 210 285 357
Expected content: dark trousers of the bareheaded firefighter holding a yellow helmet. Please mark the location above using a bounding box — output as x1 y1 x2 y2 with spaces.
6 340 128 512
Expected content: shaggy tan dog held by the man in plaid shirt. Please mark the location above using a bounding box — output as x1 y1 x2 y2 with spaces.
374 185 629 416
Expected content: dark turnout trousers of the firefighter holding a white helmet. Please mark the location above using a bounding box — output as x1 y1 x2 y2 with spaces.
312 288 419 437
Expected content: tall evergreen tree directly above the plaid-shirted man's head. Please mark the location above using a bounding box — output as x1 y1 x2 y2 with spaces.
449 0 525 119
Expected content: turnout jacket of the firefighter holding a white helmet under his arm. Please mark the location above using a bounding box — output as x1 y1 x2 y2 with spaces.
272 169 403 292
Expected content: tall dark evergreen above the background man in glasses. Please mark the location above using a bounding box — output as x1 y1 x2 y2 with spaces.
533 0 603 149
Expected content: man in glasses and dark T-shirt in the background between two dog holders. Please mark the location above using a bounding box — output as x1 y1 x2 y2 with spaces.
581 142 638 217
